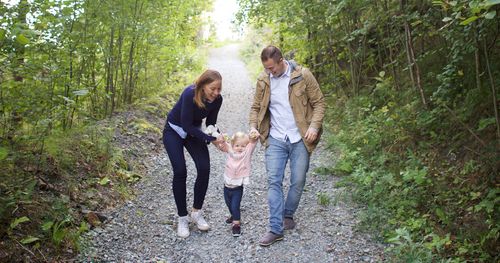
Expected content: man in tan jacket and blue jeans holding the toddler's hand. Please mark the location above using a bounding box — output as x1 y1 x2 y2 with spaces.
250 46 325 246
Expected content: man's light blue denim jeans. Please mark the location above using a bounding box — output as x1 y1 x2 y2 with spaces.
266 136 310 235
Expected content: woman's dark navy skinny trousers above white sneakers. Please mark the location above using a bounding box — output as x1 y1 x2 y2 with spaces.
163 124 210 216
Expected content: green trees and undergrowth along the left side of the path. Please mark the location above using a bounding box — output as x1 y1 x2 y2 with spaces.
0 0 211 261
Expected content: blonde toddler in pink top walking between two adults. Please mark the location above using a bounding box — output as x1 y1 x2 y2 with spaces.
220 131 259 237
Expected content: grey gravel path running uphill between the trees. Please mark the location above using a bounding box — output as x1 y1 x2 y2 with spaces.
78 45 384 262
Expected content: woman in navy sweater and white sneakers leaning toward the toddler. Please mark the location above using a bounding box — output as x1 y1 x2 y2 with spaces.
163 70 224 238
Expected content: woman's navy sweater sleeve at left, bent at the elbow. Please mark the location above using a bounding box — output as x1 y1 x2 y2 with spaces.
181 89 218 142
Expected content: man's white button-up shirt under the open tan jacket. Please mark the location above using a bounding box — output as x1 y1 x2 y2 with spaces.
269 60 302 143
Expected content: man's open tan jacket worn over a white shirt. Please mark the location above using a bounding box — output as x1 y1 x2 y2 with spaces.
249 61 325 153
